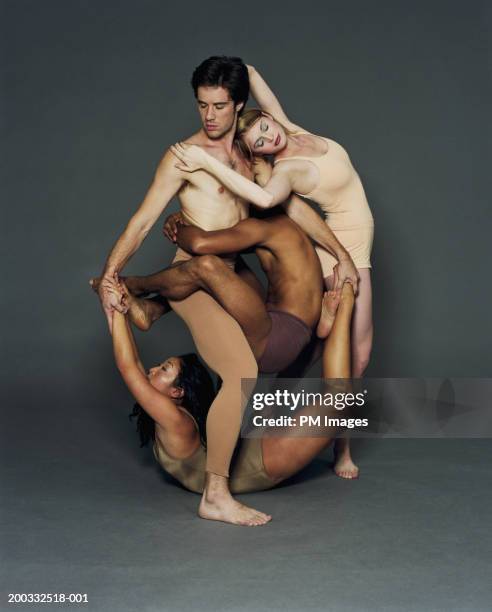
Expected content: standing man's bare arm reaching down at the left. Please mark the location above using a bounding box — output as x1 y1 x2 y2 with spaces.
99 151 186 330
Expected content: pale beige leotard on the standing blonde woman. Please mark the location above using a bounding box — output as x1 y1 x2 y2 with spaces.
274 130 374 278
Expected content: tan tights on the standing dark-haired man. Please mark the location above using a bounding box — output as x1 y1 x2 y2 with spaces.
169 249 258 478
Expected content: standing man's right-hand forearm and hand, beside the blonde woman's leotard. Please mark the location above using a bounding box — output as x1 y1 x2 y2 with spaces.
283 196 359 293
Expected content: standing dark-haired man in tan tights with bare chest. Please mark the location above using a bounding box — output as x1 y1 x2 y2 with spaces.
95 57 357 525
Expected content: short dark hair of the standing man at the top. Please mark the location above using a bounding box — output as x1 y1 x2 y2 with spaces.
191 55 249 106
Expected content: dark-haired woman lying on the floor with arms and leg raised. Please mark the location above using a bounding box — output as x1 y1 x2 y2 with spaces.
104 280 354 525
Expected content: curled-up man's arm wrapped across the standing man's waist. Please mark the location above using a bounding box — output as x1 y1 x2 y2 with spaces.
177 219 270 255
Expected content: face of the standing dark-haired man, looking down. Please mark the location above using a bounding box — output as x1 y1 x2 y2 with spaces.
197 86 243 140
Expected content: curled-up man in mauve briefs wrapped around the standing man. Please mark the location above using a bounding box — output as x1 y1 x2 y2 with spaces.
117 214 330 373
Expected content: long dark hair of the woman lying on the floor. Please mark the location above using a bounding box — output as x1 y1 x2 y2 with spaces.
129 353 216 447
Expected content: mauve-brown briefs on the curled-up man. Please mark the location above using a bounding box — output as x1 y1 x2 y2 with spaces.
258 304 312 374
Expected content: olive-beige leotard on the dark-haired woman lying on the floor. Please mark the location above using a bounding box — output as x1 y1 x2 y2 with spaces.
154 436 279 493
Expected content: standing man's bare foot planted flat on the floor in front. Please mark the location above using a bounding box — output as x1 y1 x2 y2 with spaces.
198 473 272 527
